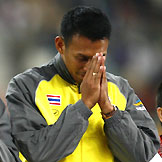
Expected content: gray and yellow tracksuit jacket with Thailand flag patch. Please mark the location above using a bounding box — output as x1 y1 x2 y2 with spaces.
6 54 159 162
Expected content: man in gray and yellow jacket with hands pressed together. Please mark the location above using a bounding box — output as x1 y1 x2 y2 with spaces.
6 6 159 162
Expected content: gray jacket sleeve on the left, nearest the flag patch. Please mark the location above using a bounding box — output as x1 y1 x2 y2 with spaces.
6 80 92 162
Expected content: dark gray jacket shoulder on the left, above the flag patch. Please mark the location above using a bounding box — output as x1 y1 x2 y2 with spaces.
7 59 57 94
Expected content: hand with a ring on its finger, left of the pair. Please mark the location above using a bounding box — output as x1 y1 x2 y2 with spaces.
80 54 102 109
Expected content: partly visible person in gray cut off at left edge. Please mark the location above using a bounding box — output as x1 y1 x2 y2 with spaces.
0 99 20 162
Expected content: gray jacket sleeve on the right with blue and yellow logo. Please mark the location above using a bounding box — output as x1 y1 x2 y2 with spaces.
104 81 159 162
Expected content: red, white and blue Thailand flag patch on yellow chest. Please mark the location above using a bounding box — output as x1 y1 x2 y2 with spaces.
47 94 61 106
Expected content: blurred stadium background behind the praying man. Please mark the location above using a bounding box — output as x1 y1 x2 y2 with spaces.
0 0 162 126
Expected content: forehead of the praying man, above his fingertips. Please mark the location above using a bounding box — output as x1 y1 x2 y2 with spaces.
68 34 109 55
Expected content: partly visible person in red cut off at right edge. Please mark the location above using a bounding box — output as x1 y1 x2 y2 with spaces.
156 82 162 157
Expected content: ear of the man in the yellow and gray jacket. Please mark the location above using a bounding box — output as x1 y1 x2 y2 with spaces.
55 36 65 54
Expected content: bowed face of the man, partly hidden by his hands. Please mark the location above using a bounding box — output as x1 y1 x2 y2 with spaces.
57 34 109 83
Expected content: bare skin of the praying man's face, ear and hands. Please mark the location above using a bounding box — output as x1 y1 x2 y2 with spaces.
55 34 113 113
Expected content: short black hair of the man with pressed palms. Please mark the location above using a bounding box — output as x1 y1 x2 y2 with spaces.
61 6 111 43
